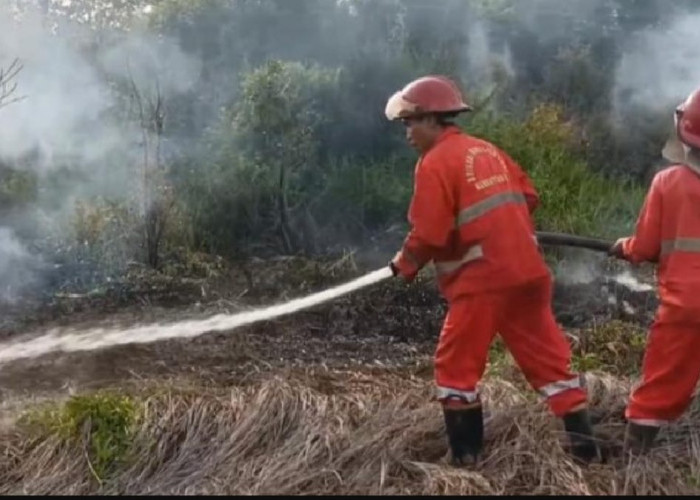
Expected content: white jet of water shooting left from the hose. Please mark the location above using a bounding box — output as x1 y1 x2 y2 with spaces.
0 266 392 363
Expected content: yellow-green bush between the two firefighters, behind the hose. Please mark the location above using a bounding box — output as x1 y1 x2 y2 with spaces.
465 105 645 238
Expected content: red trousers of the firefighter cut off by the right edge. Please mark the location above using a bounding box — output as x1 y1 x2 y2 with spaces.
625 305 700 427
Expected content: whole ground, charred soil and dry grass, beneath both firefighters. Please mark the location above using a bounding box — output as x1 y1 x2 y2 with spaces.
0 254 700 495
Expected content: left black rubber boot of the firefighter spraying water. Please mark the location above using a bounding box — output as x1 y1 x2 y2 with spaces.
443 405 484 466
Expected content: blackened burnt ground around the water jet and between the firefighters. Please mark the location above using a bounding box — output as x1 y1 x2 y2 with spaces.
0 254 655 406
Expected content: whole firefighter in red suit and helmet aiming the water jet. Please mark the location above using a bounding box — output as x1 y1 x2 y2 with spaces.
385 76 599 464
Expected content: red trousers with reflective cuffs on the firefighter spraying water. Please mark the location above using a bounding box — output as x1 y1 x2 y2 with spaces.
435 276 587 417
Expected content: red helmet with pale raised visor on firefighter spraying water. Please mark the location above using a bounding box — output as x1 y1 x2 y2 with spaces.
384 75 471 120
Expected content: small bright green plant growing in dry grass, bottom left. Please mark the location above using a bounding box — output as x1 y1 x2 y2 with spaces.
23 392 138 483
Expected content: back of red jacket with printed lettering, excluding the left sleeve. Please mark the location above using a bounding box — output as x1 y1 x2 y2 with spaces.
431 133 549 297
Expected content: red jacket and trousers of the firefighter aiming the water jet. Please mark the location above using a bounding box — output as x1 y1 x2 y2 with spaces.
393 126 587 416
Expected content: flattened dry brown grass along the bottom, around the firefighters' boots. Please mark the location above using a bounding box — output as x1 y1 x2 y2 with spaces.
0 369 700 495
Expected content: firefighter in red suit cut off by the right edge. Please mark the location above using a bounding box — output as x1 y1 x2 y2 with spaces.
610 88 700 453
